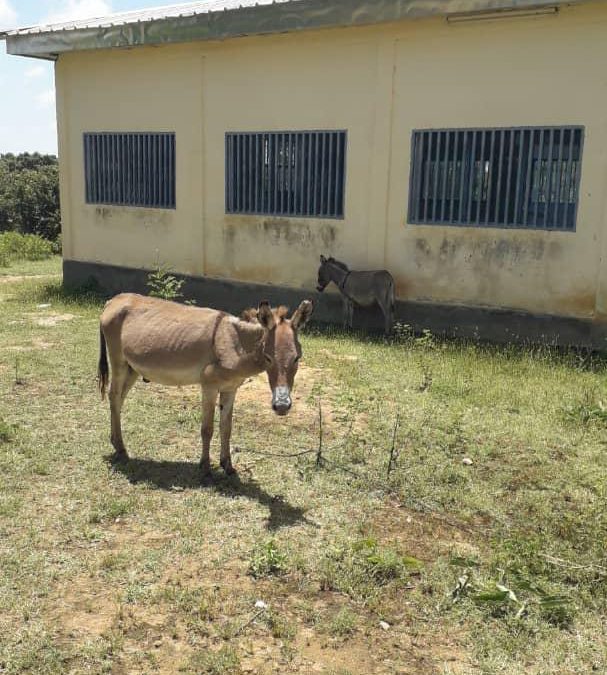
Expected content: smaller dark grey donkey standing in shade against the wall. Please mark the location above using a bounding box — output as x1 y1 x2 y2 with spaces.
316 255 394 335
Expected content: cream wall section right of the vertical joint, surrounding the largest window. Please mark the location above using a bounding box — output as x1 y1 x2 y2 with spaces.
385 6 607 317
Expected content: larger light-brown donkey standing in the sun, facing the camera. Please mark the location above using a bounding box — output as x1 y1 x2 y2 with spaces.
98 293 314 476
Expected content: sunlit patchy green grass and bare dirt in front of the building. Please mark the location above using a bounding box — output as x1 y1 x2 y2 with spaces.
0 260 607 675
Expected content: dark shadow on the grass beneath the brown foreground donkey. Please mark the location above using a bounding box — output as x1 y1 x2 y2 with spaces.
105 455 318 530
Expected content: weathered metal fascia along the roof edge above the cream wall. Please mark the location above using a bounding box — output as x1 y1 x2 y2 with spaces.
0 0 588 59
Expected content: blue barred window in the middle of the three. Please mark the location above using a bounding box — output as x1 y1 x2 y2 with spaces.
226 131 346 218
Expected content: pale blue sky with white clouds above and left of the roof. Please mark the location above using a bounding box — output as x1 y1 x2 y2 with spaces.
0 0 179 154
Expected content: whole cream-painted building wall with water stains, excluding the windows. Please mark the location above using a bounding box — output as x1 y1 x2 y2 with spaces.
56 2 607 317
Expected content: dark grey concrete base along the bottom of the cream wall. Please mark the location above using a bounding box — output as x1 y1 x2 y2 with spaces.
63 260 607 351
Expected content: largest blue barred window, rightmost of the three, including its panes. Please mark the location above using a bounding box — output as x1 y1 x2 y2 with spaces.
409 127 584 231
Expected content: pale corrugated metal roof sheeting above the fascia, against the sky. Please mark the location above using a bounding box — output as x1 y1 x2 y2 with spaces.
4 0 292 36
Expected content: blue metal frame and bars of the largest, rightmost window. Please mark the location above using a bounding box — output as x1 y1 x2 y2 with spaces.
406 124 586 233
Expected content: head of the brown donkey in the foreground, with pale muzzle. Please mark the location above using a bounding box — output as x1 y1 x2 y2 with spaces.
257 300 314 415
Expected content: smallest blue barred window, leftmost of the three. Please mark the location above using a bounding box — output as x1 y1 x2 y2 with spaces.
84 132 175 209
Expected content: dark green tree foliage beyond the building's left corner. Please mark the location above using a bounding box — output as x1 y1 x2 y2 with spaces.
0 153 61 241
